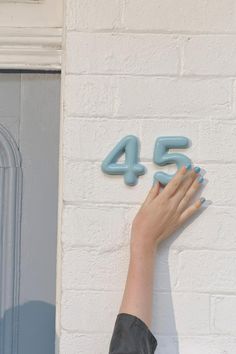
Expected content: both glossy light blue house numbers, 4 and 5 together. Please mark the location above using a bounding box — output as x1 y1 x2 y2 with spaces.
101 135 191 186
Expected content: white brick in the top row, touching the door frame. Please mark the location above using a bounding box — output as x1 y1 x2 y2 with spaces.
66 0 122 31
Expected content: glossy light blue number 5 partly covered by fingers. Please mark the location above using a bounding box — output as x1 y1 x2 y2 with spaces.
153 136 191 185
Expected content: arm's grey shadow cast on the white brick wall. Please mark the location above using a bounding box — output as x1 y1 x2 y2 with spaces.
153 201 207 354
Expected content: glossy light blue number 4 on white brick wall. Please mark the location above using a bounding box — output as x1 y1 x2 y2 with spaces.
102 135 145 186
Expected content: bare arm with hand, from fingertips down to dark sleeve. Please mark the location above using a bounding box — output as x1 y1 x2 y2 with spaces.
119 166 205 327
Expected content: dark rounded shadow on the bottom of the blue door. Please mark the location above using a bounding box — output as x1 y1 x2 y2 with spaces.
0 301 55 354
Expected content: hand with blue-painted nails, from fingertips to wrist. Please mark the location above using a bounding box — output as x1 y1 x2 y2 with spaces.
131 166 205 253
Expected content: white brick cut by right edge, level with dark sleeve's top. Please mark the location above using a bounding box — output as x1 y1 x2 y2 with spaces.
211 295 236 336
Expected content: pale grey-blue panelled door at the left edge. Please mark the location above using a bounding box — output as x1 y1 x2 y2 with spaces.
0 72 60 354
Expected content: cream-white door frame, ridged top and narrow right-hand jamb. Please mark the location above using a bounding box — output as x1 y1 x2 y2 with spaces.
0 0 65 354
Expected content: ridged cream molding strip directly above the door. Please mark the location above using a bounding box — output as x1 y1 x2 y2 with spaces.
0 27 62 70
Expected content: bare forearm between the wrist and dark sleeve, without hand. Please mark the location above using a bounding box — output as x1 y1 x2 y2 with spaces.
119 242 156 327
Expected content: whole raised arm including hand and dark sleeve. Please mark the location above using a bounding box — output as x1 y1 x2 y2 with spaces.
109 165 205 354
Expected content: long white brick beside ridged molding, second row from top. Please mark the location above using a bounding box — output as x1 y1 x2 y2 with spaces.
67 32 180 75
